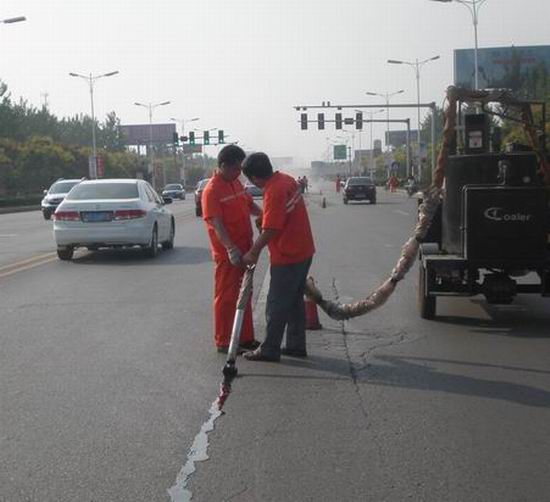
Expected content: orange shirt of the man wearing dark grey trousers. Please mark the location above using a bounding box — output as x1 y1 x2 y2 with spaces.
262 172 315 265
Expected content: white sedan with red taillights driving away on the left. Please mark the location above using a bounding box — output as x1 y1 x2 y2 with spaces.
53 179 176 260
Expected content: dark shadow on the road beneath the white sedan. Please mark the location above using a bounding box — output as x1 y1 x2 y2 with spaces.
73 246 212 266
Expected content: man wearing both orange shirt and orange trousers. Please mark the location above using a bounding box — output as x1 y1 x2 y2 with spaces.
202 145 262 353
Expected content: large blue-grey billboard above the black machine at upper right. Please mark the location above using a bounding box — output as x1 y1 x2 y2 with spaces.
454 45 550 99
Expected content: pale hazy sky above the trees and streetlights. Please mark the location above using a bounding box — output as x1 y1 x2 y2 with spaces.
0 0 550 165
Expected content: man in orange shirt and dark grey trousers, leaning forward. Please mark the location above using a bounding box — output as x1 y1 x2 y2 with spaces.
243 153 315 362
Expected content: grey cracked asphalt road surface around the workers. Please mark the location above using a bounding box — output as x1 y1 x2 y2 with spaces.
0 184 550 502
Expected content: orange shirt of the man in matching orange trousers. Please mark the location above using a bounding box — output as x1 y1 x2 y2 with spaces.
201 174 253 261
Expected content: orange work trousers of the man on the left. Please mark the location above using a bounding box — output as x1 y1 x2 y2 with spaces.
214 260 254 347
